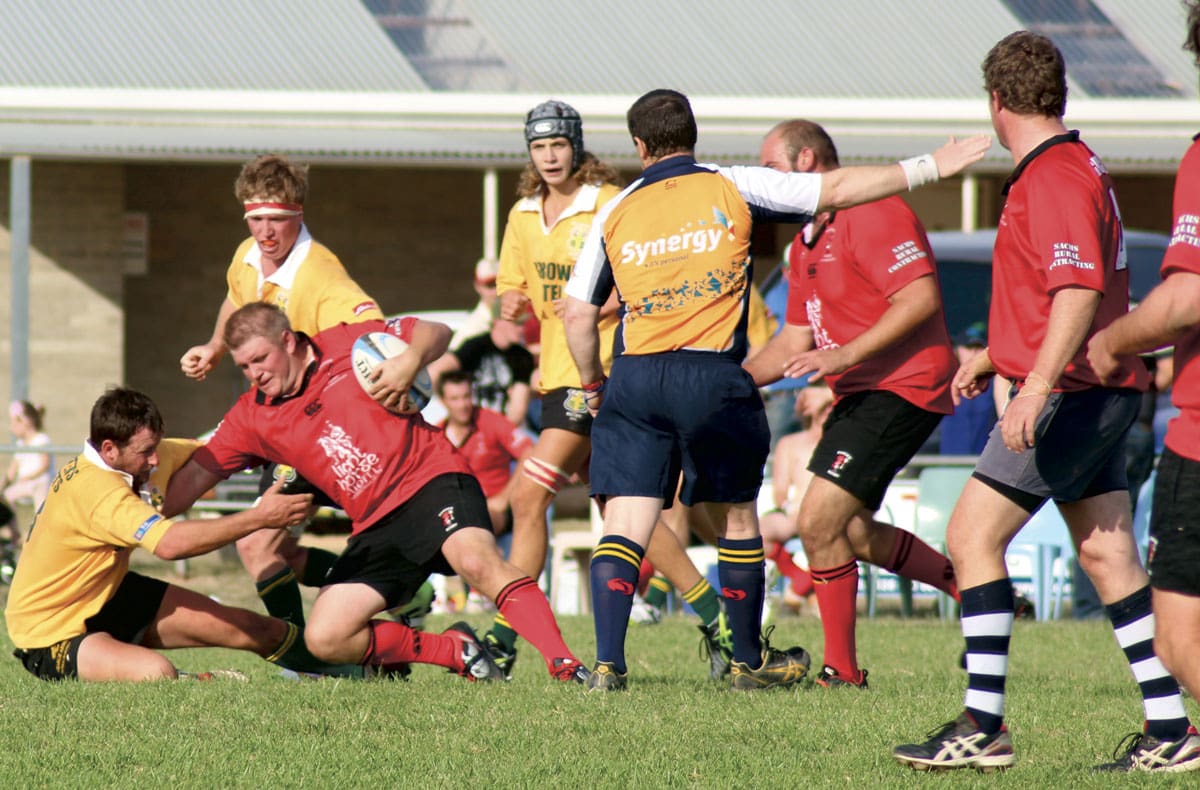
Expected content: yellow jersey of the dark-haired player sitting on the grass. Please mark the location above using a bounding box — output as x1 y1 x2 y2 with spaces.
5 439 199 650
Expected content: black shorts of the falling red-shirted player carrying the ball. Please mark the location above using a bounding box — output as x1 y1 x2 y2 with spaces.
325 473 492 609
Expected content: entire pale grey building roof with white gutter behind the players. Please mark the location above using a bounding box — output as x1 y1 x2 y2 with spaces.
0 0 1200 172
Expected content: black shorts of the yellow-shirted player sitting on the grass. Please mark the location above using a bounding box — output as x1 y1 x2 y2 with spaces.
12 570 167 681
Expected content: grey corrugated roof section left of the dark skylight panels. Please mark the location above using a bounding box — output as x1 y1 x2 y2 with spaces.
0 0 428 91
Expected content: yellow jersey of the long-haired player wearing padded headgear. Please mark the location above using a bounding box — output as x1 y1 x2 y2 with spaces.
496 184 620 393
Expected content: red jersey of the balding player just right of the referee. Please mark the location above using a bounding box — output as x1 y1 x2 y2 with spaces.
787 197 955 414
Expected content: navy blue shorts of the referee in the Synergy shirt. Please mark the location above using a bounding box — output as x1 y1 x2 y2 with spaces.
590 352 770 505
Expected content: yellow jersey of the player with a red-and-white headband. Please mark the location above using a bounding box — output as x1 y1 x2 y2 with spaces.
226 226 384 335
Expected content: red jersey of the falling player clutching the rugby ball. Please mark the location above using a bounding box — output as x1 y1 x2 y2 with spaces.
192 318 470 534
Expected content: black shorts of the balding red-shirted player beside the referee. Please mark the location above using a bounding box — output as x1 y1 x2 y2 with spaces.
809 390 942 510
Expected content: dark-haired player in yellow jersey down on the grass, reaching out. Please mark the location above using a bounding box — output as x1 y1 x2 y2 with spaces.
5 389 361 681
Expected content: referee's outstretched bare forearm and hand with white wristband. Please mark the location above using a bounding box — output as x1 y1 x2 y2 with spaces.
817 134 991 211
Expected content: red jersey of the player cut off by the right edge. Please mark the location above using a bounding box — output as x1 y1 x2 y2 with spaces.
1162 136 1200 461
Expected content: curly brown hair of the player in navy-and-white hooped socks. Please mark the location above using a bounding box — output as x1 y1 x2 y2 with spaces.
983 30 1067 118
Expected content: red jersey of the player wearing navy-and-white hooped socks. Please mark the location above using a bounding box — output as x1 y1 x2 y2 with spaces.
988 132 1147 391
